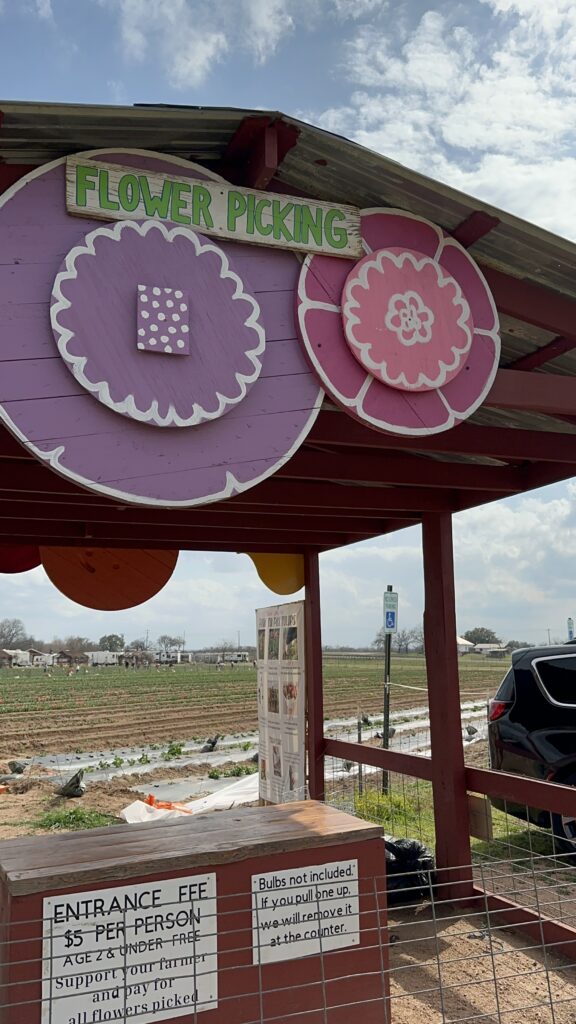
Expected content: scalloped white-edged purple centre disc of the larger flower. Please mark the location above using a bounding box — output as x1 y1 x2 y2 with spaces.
51 220 265 427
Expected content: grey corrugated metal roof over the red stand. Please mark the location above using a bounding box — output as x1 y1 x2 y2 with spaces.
0 100 576 442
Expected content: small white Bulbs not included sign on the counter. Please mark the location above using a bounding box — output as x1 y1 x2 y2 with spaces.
252 860 360 964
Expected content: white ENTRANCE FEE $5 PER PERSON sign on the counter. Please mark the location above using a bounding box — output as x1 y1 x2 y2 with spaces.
42 873 218 1024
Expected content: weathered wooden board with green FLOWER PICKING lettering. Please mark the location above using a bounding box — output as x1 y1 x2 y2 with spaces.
66 155 364 259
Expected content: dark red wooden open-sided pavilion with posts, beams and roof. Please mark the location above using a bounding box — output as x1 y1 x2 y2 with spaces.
0 102 576 951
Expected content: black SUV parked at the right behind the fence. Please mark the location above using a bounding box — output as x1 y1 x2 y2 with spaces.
488 644 576 854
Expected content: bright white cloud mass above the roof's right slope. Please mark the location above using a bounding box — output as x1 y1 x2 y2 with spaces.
306 0 576 238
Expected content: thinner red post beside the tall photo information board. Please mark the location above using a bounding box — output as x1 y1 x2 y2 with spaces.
304 551 324 800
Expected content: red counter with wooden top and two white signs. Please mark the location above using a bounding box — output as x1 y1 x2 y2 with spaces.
0 801 388 1024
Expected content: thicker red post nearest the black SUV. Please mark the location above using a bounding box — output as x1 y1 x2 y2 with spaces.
422 512 472 899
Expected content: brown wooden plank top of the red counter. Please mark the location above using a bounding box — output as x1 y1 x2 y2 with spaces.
0 800 382 896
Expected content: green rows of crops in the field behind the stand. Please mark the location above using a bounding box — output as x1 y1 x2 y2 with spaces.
0 656 505 758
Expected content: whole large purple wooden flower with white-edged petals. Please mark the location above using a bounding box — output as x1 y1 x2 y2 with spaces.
0 150 323 507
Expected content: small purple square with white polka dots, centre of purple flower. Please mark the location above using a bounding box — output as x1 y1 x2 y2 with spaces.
136 285 190 355
